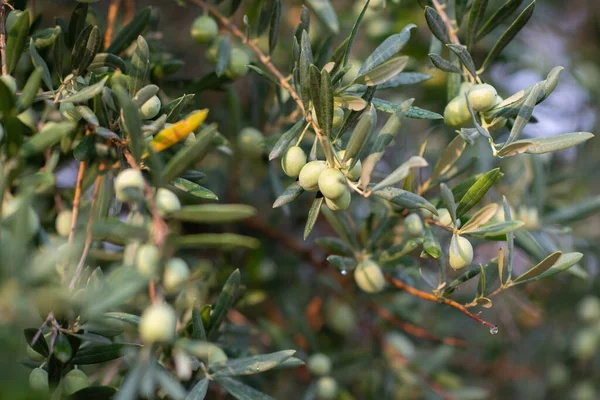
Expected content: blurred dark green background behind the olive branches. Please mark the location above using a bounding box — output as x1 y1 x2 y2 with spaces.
0 0 600 400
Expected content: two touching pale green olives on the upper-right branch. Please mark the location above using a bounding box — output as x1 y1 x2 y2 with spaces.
444 82 506 131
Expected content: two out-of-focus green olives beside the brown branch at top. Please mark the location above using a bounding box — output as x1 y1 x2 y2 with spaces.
191 15 250 79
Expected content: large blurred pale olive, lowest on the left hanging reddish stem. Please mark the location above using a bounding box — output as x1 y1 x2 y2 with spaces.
138 303 177 343
